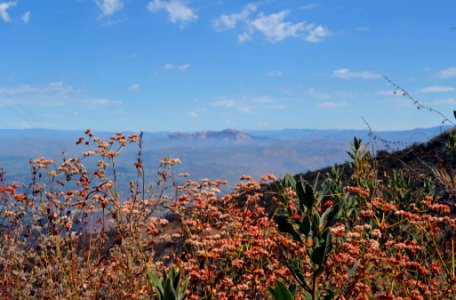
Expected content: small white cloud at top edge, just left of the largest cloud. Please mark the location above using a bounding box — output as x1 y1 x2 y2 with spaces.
147 0 198 24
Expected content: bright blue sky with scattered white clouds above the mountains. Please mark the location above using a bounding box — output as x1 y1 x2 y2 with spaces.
0 0 456 131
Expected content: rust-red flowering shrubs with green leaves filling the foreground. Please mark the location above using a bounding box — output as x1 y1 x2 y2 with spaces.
0 130 456 299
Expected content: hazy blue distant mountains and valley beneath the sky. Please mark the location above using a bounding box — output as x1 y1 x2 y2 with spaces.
0 126 450 190
